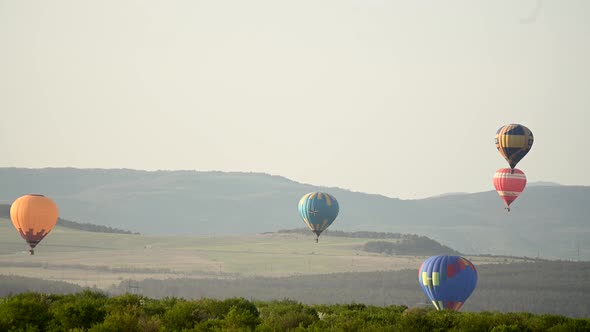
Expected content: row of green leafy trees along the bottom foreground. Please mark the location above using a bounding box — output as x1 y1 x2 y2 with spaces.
0 290 590 332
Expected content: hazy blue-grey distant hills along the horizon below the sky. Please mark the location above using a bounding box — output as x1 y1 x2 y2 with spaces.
0 168 590 260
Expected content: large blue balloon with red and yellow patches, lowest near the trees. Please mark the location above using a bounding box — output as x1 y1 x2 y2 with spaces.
418 256 477 311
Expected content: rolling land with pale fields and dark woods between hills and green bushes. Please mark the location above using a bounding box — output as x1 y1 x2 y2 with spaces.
0 210 590 317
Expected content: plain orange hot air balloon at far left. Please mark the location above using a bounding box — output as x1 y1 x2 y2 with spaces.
10 194 59 255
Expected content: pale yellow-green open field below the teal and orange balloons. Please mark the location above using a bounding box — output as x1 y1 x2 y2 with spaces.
0 219 524 288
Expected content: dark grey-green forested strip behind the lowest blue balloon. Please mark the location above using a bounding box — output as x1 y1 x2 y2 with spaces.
106 262 590 317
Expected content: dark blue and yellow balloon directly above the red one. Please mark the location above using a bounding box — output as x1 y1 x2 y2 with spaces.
496 124 534 169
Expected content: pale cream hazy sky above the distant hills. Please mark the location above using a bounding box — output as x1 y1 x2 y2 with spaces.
0 0 590 198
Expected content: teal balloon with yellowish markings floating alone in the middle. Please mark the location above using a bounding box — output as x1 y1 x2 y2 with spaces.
299 192 339 242
